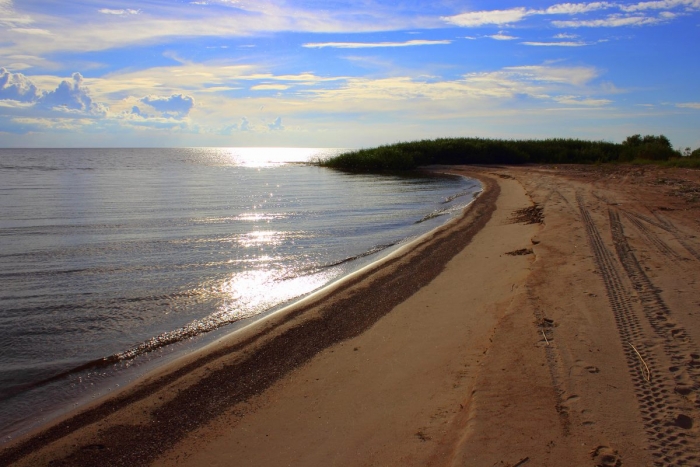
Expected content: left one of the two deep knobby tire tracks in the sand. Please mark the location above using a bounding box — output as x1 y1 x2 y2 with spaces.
577 193 699 466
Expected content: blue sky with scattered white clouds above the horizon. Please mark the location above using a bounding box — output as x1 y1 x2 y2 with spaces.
0 0 700 149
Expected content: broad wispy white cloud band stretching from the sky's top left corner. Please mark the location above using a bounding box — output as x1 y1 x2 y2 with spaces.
0 0 443 56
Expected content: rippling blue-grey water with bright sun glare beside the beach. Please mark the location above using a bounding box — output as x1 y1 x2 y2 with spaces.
0 148 480 441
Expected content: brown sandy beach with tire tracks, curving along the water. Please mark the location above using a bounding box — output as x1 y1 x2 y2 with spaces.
0 166 700 467
